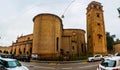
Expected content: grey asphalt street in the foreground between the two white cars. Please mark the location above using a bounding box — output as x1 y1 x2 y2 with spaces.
21 62 100 70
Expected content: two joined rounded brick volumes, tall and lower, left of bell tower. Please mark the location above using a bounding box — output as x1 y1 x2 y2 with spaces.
32 14 86 59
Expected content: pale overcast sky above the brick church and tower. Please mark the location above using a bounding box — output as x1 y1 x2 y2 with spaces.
0 0 120 46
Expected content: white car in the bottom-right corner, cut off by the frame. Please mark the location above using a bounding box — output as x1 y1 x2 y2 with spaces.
97 56 120 70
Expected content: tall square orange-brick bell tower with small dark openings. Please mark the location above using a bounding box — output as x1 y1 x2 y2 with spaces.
86 1 107 56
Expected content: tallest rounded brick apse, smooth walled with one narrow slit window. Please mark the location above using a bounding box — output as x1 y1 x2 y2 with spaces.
32 14 63 58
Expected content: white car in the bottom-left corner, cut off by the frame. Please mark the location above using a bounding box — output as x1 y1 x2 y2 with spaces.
0 58 29 70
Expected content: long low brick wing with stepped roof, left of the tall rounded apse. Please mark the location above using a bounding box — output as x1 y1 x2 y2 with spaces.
11 34 33 56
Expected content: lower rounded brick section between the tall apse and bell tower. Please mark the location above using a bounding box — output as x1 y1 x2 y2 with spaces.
61 29 86 56
